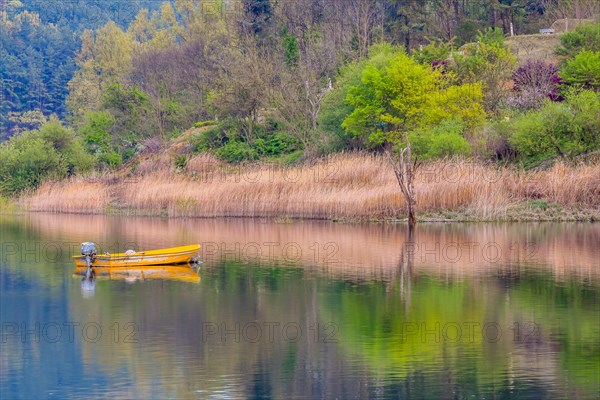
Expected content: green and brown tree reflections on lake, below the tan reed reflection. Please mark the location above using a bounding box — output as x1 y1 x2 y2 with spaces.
58 263 599 397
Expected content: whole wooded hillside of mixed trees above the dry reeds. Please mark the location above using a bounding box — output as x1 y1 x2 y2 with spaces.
0 0 600 195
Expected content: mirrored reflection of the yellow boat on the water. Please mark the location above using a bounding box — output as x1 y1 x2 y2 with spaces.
73 265 200 283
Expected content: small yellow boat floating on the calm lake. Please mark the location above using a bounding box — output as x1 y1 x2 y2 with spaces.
73 244 200 272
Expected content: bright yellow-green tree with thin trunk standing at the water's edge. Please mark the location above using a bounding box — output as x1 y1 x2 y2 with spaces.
343 46 485 229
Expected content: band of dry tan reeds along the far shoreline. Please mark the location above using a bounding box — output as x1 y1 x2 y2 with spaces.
19 154 600 220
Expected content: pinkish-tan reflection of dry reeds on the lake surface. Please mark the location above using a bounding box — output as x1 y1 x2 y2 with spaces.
11 214 600 280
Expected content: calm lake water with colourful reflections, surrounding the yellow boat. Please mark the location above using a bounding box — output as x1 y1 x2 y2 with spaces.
0 214 600 399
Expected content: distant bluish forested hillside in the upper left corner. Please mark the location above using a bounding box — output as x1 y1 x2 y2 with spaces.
0 0 162 138
